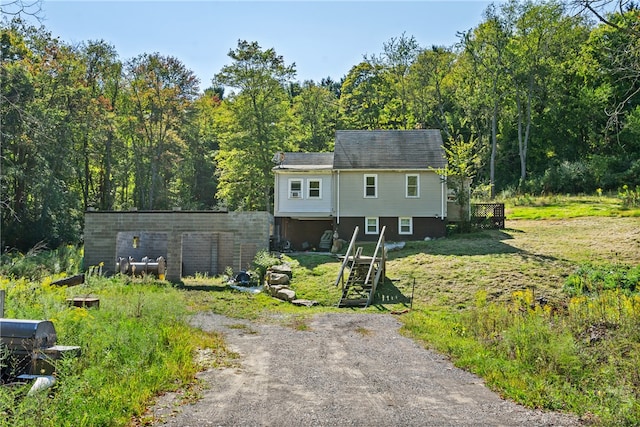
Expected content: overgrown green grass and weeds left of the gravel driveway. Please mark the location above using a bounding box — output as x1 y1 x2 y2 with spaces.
0 277 233 427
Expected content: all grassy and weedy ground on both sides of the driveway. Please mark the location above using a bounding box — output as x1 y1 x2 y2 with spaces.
0 196 640 426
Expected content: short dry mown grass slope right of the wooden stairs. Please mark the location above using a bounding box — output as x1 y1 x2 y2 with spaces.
387 217 640 308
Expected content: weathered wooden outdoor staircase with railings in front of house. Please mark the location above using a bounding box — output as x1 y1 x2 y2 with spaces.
335 227 386 307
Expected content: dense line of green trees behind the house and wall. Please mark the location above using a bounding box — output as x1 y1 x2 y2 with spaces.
0 0 640 250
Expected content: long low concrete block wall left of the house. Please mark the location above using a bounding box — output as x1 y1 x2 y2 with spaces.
84 211 273 281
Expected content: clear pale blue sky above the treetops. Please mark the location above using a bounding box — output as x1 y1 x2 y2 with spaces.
31 0 491 89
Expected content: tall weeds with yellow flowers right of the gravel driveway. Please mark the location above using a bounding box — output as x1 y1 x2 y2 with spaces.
403 291 640 426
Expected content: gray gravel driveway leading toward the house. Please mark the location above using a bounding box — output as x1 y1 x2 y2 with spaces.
154 313 580 427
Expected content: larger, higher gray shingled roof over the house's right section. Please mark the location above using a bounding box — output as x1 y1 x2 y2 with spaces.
333 129 447 169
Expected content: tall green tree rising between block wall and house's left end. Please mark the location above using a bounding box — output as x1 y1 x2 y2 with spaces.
214 40 295 211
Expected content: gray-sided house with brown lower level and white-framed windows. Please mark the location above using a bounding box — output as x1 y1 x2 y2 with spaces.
274 129 447 249
